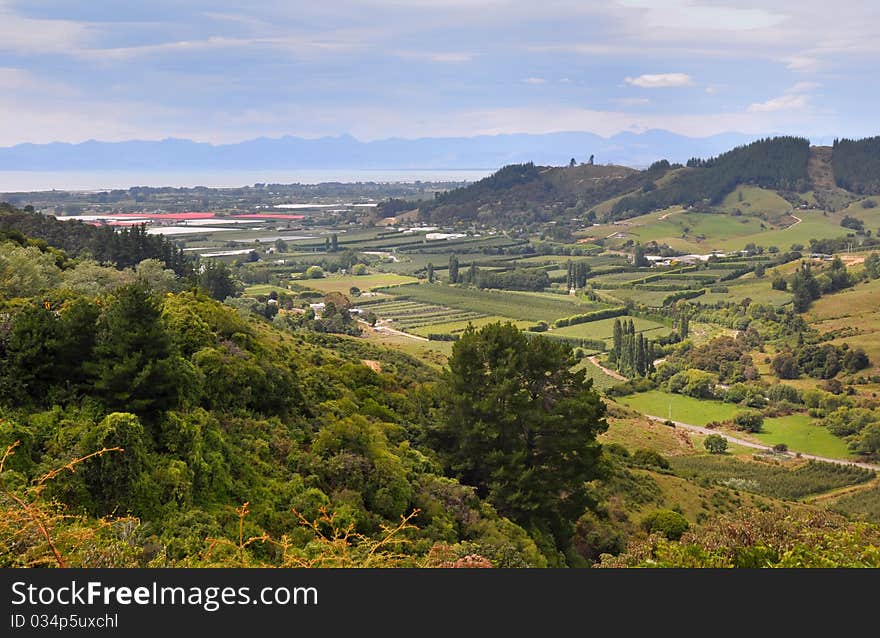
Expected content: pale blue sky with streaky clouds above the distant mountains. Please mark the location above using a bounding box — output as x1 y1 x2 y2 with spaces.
0 0 880 146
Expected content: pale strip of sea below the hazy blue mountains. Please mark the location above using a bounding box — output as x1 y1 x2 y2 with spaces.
0 168 496 193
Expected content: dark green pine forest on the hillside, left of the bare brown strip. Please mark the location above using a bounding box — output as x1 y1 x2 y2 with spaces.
611 137 810 219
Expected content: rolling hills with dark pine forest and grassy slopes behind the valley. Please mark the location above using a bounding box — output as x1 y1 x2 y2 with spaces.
413 137 880 232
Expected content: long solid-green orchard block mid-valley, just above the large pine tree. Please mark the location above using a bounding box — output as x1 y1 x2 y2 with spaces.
383 284 605 323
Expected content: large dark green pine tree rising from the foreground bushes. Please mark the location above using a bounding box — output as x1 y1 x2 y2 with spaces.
427 323 607 547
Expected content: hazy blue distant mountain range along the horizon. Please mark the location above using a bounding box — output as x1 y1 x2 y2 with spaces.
0 130 840 171
